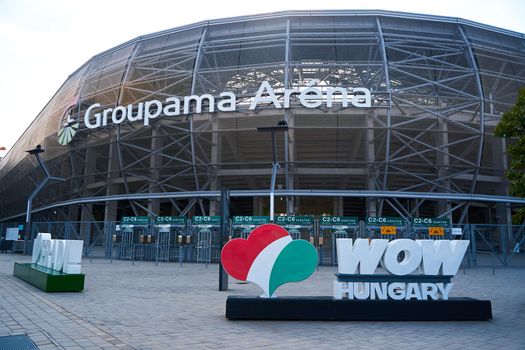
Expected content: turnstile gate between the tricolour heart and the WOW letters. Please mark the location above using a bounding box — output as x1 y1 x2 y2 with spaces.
318 216 359 266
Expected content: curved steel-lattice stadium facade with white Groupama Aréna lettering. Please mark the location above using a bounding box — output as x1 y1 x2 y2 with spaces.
0 11 525 224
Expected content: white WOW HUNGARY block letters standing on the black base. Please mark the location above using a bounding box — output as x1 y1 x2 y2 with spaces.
334 238 469 300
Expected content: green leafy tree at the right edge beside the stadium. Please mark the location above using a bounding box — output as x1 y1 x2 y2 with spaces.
494 87 525 223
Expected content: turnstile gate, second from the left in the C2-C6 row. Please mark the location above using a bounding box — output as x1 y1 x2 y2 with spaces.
153 216 187 261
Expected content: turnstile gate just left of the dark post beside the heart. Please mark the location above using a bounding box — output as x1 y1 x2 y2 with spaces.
190 216 221 263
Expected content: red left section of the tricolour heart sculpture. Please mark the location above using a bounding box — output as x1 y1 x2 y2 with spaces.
221 224 289 281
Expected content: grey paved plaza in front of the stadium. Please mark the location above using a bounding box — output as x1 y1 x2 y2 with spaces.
0 254 525 350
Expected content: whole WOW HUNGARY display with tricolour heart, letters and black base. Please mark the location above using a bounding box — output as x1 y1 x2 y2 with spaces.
221 224 492 321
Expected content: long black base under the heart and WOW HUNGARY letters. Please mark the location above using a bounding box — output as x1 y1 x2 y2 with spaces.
226 296 492 321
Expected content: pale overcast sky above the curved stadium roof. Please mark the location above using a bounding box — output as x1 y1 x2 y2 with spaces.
0 0 525 157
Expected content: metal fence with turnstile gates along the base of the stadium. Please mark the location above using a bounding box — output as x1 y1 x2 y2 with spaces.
0 220 525 268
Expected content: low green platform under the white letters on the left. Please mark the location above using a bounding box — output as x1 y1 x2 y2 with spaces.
13 263 85 292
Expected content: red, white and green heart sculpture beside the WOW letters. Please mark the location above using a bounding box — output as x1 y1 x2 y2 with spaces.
221 224 318 297
